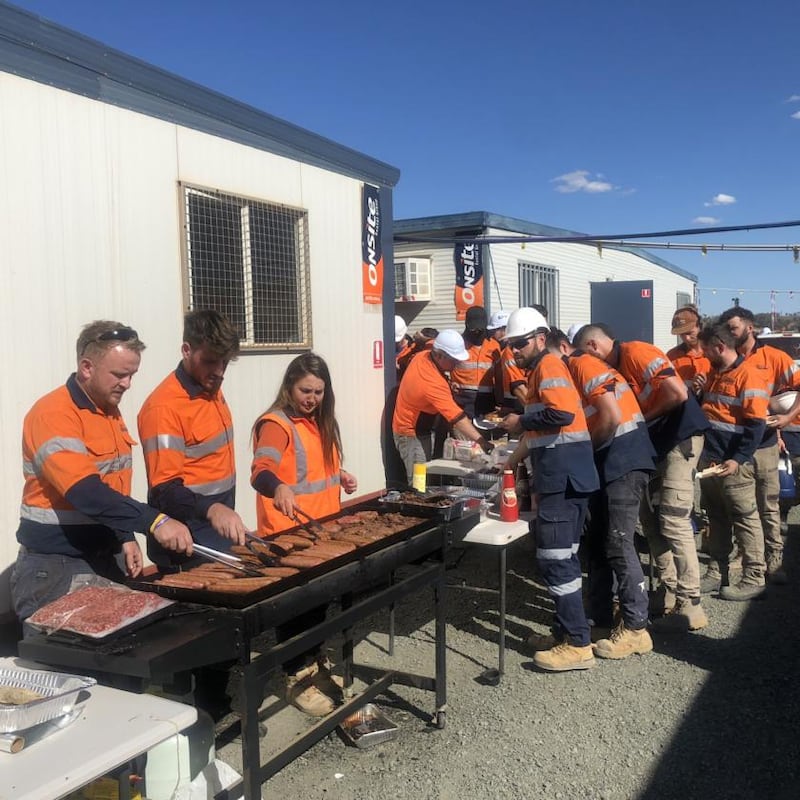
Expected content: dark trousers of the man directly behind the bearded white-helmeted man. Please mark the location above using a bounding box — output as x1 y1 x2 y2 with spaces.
586 470 650 630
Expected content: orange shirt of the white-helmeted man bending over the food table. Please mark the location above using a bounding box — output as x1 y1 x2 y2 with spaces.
392 352 465 436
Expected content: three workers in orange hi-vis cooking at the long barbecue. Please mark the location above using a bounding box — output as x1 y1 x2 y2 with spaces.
11 310 358 716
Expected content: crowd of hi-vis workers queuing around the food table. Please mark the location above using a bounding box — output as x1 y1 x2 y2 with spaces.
392 305 800 671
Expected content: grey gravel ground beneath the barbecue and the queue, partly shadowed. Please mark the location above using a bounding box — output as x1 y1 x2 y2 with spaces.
218 512 800 800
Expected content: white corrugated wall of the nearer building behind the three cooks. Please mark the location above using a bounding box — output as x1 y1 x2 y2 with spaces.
0 73 383 614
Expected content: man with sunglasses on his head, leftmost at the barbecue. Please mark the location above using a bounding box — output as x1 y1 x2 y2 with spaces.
11 320 192 635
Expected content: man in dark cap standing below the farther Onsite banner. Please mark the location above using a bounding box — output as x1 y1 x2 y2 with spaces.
450 306 503 419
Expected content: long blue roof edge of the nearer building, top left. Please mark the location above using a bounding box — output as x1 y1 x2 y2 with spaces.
0 0 400 188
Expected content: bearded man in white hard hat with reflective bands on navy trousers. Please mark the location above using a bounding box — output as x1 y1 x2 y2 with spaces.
502 308 599 672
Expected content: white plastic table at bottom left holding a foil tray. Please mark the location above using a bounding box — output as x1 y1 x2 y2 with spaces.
0 658 197 800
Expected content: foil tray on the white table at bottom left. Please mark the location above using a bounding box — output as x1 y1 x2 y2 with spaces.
0 667 97 733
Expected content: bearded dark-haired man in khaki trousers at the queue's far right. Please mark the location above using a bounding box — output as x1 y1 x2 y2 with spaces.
703 306 800 590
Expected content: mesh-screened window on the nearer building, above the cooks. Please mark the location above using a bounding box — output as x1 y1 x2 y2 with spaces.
181 185 311 350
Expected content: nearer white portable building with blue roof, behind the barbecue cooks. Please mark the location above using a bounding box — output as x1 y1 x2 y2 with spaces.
0 2 399 618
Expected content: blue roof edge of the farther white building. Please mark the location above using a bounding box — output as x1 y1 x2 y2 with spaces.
392 211 698 283
